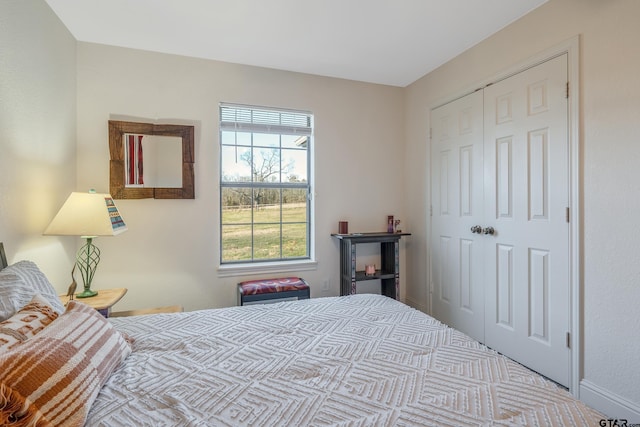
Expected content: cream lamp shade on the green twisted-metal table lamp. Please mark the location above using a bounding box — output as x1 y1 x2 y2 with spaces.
44 192 127 237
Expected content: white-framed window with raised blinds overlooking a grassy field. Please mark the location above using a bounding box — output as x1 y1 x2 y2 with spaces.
220 104 313 264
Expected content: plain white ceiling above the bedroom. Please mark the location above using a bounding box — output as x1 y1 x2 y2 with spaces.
45 0 547 87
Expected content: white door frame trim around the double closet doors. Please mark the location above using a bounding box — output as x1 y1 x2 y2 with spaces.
426 36 584 398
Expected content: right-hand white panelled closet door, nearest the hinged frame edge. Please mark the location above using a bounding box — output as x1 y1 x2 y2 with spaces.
484 55 570 386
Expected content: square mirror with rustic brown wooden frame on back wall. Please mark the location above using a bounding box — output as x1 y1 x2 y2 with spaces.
109 120 195 199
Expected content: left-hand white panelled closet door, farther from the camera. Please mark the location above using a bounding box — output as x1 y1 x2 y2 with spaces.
431 91 485 341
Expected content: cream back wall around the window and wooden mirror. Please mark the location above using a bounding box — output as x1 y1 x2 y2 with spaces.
78 43 410 310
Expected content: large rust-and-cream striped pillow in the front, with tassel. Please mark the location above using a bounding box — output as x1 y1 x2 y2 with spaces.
0 301 131 426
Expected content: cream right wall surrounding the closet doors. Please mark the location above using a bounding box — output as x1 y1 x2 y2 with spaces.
405 0 640 422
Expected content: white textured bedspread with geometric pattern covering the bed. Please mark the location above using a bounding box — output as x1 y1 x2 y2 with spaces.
86 295 603 427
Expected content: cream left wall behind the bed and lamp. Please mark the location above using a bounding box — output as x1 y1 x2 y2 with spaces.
0 0 76 289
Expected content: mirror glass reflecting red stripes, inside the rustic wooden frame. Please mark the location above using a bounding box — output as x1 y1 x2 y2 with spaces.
123 133 182 188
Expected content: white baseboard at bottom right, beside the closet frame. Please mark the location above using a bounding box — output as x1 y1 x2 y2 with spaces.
580 380 640 424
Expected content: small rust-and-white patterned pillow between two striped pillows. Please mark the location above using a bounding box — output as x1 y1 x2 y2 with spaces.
0 294 58 351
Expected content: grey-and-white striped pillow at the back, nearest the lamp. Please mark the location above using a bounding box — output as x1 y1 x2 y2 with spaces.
0 261 64 322
